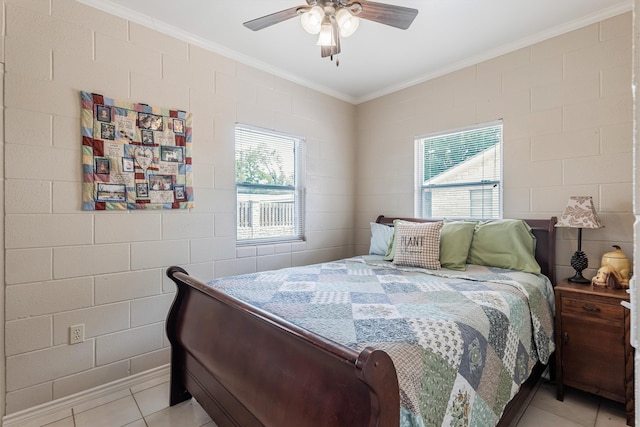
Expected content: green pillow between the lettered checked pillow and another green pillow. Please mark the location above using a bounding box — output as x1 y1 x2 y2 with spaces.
440 220 477 271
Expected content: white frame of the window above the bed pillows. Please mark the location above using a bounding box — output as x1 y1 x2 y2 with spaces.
414 119 504 220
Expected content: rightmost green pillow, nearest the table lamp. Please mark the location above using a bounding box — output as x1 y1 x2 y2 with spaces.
467 219 540 274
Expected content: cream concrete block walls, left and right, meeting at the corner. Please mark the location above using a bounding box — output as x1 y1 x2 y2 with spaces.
0 0 633 413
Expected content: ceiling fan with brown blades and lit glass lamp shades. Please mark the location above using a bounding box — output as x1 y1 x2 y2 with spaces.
243 0 418 65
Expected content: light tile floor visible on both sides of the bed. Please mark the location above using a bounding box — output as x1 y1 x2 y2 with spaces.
33 379 626 427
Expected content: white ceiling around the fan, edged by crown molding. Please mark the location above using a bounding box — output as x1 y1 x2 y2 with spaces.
77 0 633 104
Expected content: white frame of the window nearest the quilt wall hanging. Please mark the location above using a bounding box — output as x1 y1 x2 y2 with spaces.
233 123 306 246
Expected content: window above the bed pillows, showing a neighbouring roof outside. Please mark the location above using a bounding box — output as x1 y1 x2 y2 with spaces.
416 121 502 219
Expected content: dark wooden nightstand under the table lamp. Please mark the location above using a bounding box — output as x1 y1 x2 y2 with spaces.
555 280 634 425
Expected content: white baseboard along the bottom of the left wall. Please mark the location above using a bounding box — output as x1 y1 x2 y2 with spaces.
0 364 170 427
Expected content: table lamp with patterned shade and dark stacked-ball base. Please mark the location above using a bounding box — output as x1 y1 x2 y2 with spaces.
556 196 604 284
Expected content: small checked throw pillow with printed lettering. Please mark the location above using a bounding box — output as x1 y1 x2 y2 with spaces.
393 221 442 270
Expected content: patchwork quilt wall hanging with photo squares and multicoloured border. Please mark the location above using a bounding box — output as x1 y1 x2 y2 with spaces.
80 92 194 210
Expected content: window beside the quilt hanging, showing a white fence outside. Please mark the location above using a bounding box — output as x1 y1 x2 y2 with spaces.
235 125 303 244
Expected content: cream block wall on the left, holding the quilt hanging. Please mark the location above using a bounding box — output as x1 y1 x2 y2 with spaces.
0 0 356 414
